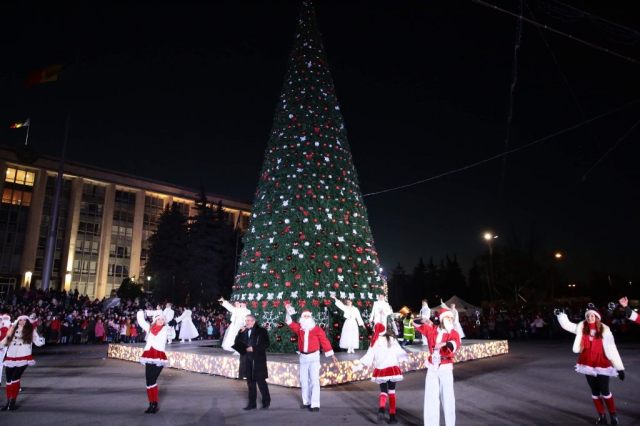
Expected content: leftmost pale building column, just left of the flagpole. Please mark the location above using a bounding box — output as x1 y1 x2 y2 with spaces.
20 169 47 286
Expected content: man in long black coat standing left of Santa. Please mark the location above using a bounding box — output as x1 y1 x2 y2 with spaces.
233 315 271 410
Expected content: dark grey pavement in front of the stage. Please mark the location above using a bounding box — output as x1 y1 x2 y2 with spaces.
0 339 640 426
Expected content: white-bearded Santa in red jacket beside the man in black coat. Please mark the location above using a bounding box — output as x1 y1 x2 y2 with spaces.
285 305 338 412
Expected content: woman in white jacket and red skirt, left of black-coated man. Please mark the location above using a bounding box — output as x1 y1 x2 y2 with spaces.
137 311 169 414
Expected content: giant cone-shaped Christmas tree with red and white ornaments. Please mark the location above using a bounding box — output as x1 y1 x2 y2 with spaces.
231 1 386 352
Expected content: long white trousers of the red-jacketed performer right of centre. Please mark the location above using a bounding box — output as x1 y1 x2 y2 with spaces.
424 369 456 426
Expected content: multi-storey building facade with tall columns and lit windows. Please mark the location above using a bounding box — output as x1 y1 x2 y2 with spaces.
0 147 251 298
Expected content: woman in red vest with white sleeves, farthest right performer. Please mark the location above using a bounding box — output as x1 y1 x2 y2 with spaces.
556 305 624 425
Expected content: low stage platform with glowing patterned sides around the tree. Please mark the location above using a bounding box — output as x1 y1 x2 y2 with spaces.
107 339 509 387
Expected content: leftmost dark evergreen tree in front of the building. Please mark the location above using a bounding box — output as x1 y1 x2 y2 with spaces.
145 203 189 302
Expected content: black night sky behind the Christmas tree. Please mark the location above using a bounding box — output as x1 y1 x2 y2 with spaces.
0 0 640 280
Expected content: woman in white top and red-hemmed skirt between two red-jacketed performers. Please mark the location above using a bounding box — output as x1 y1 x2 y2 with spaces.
353 323 408 424
